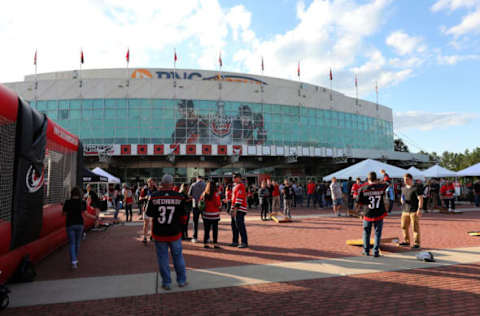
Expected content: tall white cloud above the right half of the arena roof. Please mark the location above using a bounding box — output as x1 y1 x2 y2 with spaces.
234 0 402 94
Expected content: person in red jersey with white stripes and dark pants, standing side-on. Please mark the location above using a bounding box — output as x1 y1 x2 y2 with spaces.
230 173 248 248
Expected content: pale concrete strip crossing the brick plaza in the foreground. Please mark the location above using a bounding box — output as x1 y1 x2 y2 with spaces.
10 247 480 307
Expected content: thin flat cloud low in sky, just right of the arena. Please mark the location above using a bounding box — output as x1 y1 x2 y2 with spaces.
393 111 478 131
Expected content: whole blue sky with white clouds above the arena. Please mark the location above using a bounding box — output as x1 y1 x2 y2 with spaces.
0 0 480 152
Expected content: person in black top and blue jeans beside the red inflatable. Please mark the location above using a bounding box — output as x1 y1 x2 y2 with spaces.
63 187 96 269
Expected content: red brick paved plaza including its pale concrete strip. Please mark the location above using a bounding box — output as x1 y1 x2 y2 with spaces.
2 209 480 315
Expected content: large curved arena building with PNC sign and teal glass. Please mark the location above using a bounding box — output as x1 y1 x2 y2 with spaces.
2 68 427 182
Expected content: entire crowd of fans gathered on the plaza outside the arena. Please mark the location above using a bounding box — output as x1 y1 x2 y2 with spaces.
63 170 480 290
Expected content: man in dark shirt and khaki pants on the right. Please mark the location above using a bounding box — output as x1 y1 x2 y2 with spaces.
400 173 423 249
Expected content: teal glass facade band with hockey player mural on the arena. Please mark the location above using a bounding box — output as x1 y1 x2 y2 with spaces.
31 99 393 150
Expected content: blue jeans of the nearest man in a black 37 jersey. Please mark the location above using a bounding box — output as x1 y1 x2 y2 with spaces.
155 239 187 285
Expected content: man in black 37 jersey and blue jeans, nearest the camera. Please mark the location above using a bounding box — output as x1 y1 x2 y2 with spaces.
146 174 187 291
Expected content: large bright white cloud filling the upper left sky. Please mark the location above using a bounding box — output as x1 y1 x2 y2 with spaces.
0 0 251 82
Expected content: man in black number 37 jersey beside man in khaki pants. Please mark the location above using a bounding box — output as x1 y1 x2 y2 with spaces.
357 171 388 257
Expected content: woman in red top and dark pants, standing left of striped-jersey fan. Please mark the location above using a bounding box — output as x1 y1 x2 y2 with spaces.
200 181 222 249
